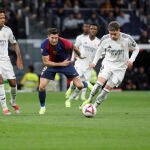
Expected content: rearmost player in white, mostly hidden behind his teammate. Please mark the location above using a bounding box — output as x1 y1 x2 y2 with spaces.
65 22 90 100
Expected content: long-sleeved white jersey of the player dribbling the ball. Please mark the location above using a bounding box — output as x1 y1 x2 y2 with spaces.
93 33 139 69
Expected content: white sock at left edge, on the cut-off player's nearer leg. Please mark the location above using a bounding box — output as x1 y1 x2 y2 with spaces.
0 84 8 110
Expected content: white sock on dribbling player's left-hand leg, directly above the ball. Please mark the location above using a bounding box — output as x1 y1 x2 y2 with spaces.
88 82 103 102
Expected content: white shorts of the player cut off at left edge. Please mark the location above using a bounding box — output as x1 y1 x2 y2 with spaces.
0 61 16 79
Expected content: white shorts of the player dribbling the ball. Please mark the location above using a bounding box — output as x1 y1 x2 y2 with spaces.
98 66 126 88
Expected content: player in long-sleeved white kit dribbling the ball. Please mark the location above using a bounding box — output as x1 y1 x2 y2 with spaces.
80 21 139 109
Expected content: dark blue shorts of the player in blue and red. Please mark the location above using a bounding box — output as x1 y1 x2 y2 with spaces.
41 63 79 80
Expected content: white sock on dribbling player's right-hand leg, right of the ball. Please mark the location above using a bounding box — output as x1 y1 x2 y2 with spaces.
94 89 110 107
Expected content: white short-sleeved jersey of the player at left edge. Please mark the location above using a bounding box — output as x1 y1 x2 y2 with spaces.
0 25 16 60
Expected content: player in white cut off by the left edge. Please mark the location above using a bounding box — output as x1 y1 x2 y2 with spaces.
0 10 23 115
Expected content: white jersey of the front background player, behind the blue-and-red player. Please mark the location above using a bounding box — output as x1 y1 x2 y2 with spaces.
75 35 100 70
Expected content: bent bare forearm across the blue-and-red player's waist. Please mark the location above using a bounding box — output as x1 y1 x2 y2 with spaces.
42 56 70 67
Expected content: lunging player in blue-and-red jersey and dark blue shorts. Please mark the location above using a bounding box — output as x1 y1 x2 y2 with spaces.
39 28 88 115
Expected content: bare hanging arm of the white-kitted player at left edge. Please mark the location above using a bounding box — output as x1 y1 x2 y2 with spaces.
13 42 23 69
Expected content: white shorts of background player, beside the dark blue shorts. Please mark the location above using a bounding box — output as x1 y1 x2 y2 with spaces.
75 67 91 81
